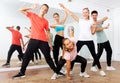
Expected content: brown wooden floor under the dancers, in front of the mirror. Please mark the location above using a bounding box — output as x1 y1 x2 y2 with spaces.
0 62 120 83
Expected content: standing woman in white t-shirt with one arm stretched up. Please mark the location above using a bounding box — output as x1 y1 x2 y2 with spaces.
60 4 106 76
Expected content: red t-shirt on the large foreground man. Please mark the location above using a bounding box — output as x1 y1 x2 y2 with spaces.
27 12 49 41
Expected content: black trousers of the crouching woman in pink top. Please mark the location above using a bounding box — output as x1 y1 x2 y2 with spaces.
57 55 87 72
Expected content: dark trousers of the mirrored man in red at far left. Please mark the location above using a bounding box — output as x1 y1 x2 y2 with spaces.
6 44 23 63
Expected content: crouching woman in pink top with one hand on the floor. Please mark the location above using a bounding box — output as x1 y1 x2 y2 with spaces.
58 26 89 80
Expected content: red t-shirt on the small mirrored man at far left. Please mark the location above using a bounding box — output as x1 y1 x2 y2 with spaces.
9 28 22 46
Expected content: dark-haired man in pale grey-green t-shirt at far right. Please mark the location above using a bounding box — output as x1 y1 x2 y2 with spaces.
91 10 115 71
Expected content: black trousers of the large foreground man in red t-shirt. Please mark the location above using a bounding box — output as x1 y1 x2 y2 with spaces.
20 39 57 74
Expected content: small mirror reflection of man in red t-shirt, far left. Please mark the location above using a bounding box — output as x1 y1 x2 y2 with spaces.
2 26 24 67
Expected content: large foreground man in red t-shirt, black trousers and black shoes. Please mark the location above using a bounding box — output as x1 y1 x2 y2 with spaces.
13 4 60 78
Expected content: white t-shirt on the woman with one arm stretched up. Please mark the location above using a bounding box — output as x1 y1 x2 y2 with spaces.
78 19 93 41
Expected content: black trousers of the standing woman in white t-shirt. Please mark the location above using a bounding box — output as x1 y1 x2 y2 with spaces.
77 41 101 69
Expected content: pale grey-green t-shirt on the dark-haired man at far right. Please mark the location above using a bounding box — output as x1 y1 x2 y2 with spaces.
96 23 108 43
